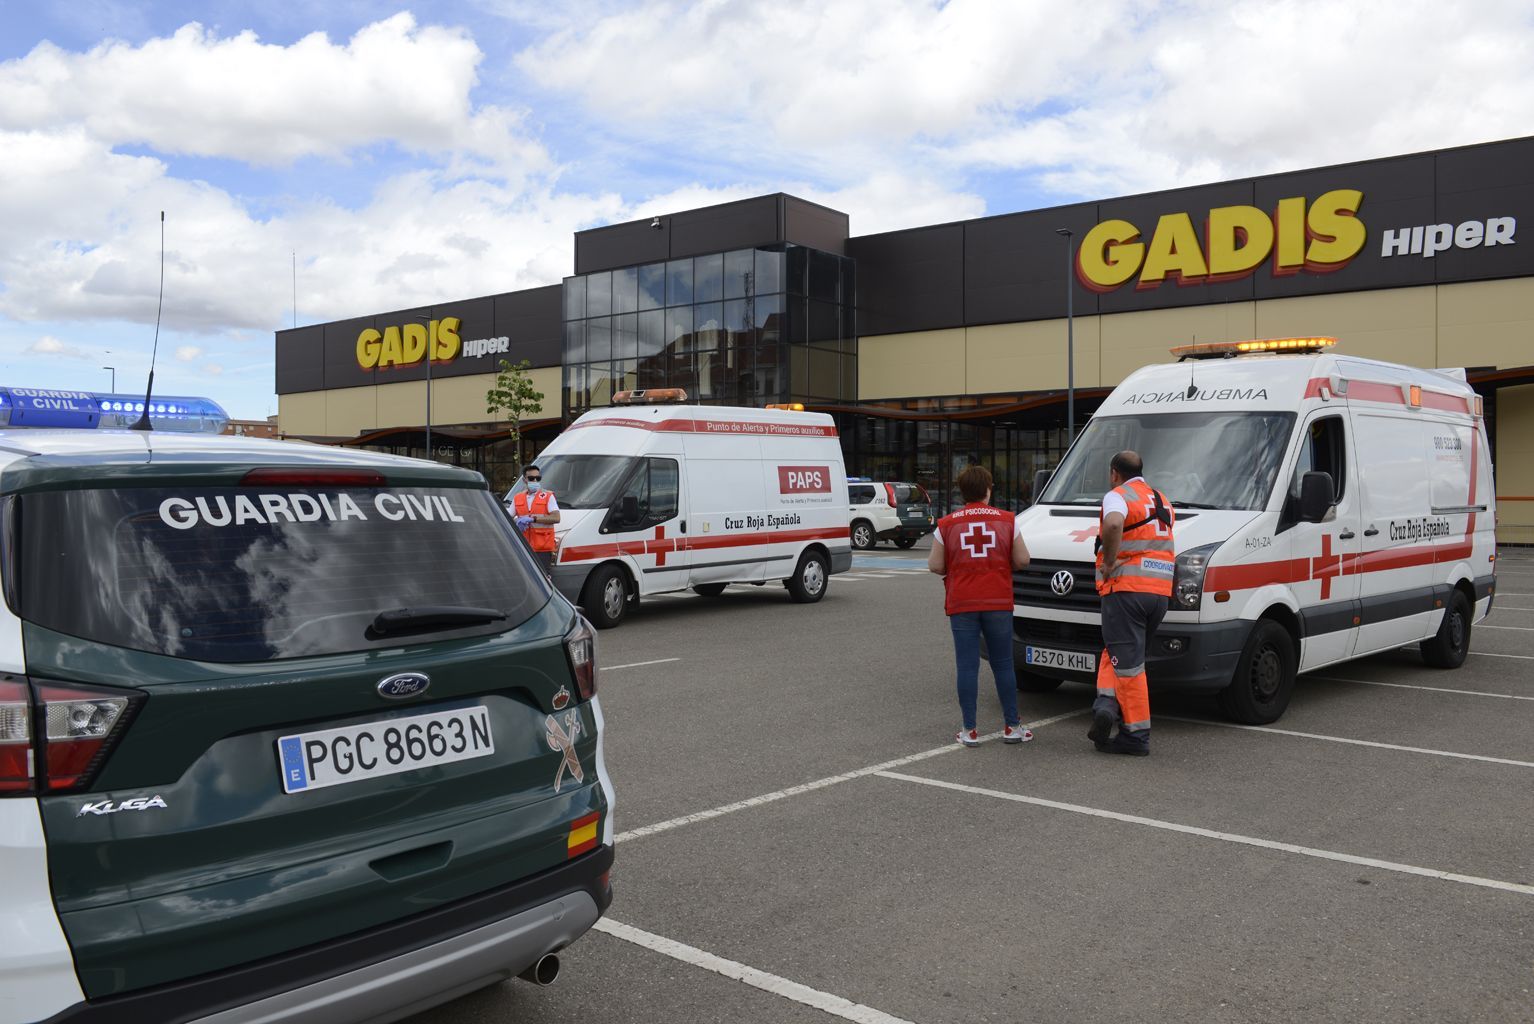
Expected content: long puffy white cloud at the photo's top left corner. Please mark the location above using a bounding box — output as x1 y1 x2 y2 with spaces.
0 12 548 166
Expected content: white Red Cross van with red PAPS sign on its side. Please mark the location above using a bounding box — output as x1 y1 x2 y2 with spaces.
508 389 853 629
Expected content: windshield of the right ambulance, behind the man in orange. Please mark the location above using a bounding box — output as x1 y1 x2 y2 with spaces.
1040 412 1295 510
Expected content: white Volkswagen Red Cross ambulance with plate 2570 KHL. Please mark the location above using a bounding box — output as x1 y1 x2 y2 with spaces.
1014 339 1496 724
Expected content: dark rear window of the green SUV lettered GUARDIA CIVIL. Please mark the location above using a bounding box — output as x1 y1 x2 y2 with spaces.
6 487 549 662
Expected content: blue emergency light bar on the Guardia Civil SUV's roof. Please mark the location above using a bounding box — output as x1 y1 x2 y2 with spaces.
0 388 229 434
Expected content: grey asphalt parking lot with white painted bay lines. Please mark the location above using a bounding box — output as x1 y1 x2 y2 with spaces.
413 547 1534 1024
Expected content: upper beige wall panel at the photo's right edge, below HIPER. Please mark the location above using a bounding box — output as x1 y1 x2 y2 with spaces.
1437 277 1534 366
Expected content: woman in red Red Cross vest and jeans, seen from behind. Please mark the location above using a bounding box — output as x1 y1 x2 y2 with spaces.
927 466 1034 747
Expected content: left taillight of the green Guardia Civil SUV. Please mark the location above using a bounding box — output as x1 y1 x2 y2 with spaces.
0 678 144 794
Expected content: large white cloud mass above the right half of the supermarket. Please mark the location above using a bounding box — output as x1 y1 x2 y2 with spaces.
518 0 1534 202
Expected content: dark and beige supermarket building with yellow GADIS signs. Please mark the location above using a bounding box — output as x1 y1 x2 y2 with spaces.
276 138 1534 543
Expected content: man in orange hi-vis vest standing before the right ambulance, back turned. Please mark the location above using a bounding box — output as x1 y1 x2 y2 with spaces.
1086 452 1177 757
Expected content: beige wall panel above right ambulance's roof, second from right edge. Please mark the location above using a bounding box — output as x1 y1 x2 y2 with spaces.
1256 287 1437 366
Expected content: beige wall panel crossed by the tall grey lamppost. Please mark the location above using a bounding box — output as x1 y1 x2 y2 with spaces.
965 316 1101 394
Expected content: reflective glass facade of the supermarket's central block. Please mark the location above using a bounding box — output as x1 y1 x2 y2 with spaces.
563 245 858 420
